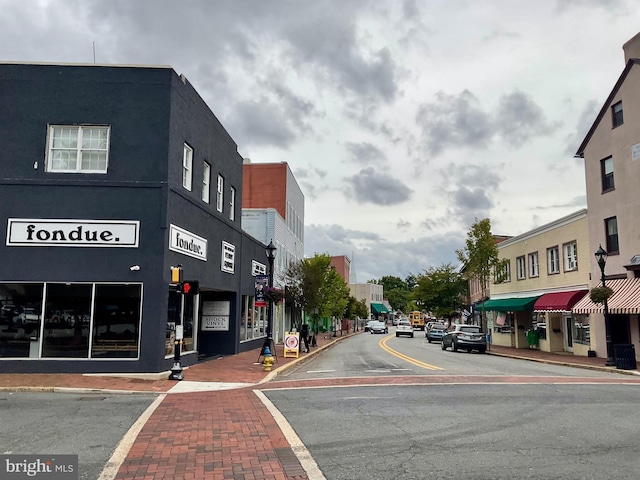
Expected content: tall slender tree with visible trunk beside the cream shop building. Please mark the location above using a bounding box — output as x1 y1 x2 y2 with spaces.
456 218 500 331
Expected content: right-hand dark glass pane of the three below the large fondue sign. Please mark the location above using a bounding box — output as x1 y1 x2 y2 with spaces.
91 284 141 358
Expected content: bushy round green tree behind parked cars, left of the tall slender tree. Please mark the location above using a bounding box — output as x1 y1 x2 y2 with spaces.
412 263 468 320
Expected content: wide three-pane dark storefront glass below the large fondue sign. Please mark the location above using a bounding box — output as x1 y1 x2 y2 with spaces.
0 283 142 359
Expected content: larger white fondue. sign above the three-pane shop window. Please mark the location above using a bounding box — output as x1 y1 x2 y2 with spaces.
7 218 140 248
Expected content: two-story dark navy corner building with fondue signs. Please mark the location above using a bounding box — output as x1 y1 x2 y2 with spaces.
0 63 268 373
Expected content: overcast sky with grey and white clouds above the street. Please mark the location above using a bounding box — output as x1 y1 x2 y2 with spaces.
0 0 640 282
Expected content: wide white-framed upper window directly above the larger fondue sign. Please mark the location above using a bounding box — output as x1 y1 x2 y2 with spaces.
47 125 110 173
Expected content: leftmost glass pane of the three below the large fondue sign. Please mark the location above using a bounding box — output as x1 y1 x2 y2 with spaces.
0 283 44 358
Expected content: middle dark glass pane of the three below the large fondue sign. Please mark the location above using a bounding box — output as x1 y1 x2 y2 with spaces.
42 283 93 358
